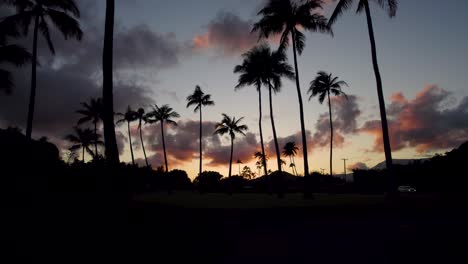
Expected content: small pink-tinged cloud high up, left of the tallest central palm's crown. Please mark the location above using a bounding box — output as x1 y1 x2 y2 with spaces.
193 12 258 55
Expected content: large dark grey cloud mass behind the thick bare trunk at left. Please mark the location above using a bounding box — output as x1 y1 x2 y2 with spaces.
0 1 183 157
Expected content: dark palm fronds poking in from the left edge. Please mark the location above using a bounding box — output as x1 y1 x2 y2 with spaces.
0 21 32 94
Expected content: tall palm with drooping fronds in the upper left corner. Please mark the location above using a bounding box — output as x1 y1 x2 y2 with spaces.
3 0 83 139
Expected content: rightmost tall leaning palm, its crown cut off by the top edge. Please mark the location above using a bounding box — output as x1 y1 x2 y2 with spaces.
328 0 398 194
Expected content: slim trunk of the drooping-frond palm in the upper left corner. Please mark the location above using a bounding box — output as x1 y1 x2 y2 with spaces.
26 15 39 140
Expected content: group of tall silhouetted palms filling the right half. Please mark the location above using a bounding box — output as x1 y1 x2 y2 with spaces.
234 0 397 192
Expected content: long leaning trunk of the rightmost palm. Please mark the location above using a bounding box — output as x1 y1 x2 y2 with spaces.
364 1 396 194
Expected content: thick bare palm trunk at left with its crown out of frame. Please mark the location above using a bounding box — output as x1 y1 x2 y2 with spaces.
102 0 119 164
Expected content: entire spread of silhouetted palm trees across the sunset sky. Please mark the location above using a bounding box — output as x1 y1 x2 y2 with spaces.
0 0 397 194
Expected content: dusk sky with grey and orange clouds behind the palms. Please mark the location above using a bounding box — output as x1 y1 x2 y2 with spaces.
0 0 468 178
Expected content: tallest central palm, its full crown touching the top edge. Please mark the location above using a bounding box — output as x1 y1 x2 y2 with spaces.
252 0 331 176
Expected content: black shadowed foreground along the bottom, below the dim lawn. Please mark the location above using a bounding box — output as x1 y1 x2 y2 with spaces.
1 195 468 263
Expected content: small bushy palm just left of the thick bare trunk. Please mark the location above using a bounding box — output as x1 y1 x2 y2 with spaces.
65 127 104 162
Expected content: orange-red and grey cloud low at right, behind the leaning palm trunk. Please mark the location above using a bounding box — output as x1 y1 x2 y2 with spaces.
361 85 468 153
